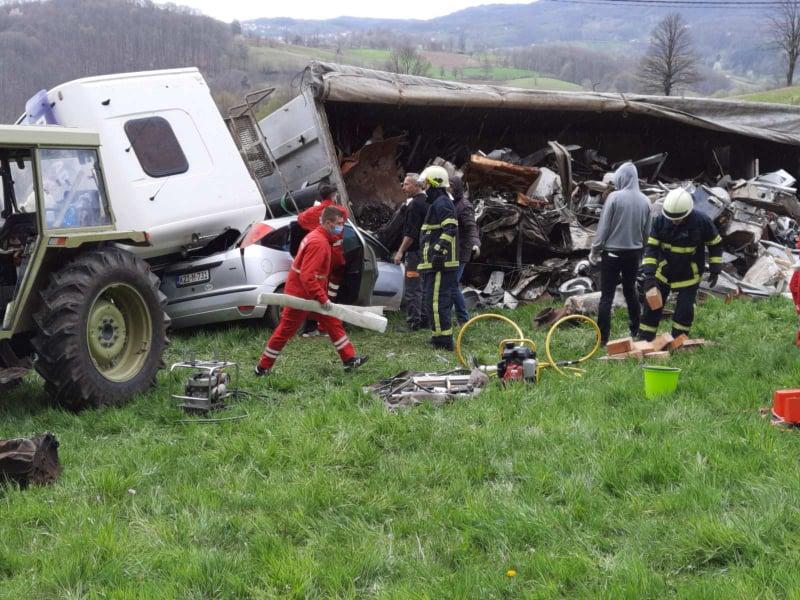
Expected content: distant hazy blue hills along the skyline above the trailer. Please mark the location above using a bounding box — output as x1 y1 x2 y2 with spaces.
243 0 779 85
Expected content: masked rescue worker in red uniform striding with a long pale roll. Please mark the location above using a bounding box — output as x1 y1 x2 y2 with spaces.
255 206 367 377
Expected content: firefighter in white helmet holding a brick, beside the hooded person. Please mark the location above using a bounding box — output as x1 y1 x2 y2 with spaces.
639 188 722 341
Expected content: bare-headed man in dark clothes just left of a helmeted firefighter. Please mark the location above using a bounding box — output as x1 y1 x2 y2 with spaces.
394 173 428 330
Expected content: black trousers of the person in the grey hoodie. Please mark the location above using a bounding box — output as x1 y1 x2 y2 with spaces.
597 250 641 342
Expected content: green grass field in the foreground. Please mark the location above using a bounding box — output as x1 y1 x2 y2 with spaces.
0 300 800 599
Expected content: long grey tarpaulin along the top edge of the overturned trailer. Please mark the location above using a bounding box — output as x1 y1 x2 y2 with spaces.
306 62 800 146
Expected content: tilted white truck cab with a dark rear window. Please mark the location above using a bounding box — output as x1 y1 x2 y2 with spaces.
19 68 266 258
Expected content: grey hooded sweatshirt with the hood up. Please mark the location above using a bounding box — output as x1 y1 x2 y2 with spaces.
592 162 650 251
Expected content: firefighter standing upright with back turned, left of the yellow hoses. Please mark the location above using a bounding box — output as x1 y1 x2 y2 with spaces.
417 166 458 350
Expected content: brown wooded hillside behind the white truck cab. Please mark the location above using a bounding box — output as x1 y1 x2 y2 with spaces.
0 0 253 122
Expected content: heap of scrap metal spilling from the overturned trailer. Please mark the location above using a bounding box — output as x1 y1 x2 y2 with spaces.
356 138 800 304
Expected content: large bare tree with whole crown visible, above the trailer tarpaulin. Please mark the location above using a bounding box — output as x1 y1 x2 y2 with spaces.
639 13 700 96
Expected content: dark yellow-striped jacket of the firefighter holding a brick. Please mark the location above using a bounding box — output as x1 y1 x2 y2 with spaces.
642 211 722 289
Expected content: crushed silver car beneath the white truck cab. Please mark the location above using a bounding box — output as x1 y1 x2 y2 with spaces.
161 216 404 328
